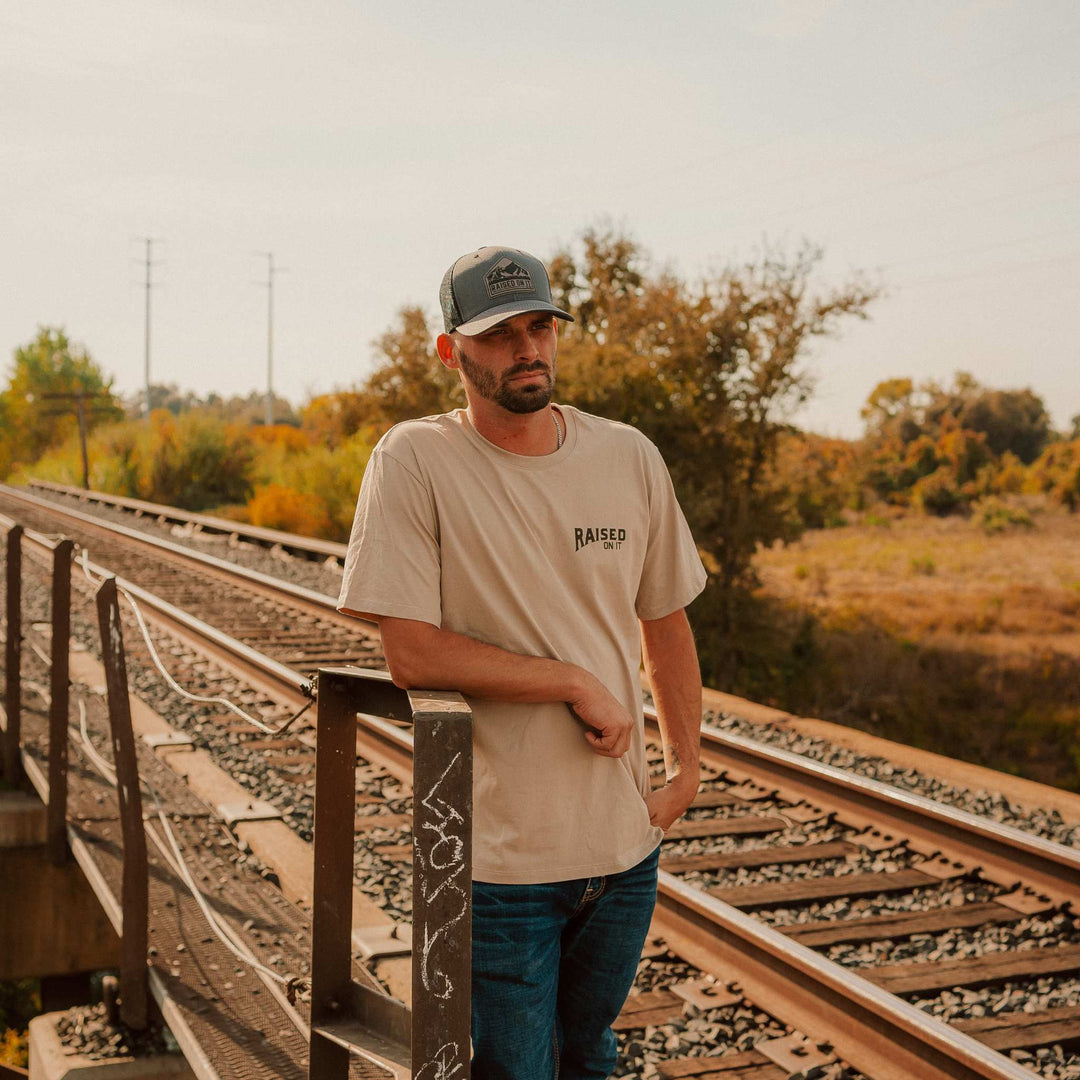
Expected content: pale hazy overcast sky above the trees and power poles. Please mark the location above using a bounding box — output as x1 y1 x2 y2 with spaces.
0 0 1080 435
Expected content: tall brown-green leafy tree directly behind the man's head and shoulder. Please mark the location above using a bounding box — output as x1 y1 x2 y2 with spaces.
551 231 878 663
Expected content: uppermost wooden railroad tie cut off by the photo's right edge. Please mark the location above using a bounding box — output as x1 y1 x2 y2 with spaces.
859 945 1080 994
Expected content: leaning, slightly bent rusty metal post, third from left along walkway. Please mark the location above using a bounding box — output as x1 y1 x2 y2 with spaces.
96 577 149 1030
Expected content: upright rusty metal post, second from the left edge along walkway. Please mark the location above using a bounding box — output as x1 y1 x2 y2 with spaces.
45 539 75 866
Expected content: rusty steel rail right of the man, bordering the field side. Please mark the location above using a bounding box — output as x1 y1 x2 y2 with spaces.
647 710 1080 906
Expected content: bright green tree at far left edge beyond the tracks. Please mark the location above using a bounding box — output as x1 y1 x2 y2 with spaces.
0 326 123 476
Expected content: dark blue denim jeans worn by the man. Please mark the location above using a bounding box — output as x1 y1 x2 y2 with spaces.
472 847 660 1080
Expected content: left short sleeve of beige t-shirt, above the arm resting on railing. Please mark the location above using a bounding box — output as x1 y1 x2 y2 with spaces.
337 448 443 626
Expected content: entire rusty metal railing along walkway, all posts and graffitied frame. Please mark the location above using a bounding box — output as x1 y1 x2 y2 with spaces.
0 515 472 1080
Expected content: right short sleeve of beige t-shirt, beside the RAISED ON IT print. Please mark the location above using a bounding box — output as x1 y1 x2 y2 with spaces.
634 444 706 620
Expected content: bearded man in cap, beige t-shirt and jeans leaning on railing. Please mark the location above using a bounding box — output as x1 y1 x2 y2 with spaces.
338 247 705 1080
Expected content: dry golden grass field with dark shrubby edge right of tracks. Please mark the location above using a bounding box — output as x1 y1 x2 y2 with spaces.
755 504 1080 789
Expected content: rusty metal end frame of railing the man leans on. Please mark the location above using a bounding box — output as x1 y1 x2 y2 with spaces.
309 667 472 1080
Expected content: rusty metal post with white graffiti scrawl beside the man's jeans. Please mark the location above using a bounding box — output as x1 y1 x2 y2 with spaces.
408 690 472 1080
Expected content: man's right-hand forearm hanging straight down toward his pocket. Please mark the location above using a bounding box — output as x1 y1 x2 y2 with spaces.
642 610 701 791
